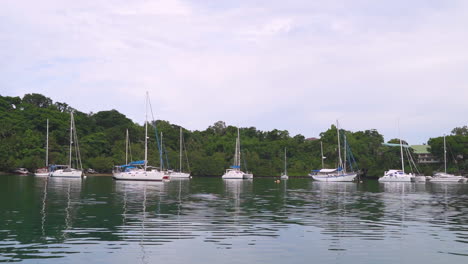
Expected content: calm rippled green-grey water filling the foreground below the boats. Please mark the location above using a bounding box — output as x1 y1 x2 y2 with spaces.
0 175 468 264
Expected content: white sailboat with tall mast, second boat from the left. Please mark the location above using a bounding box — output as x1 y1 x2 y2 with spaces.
50 111 83 178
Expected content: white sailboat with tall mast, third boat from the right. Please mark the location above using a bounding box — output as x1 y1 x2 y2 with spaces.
309 120 357 182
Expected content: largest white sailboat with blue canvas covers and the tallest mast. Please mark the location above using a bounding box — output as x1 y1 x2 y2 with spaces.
112 92 169 181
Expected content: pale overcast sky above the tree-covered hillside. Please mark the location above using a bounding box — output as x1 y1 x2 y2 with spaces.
0 0 468 144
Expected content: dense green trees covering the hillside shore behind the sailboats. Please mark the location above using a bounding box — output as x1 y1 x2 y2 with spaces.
0 94 468 176
